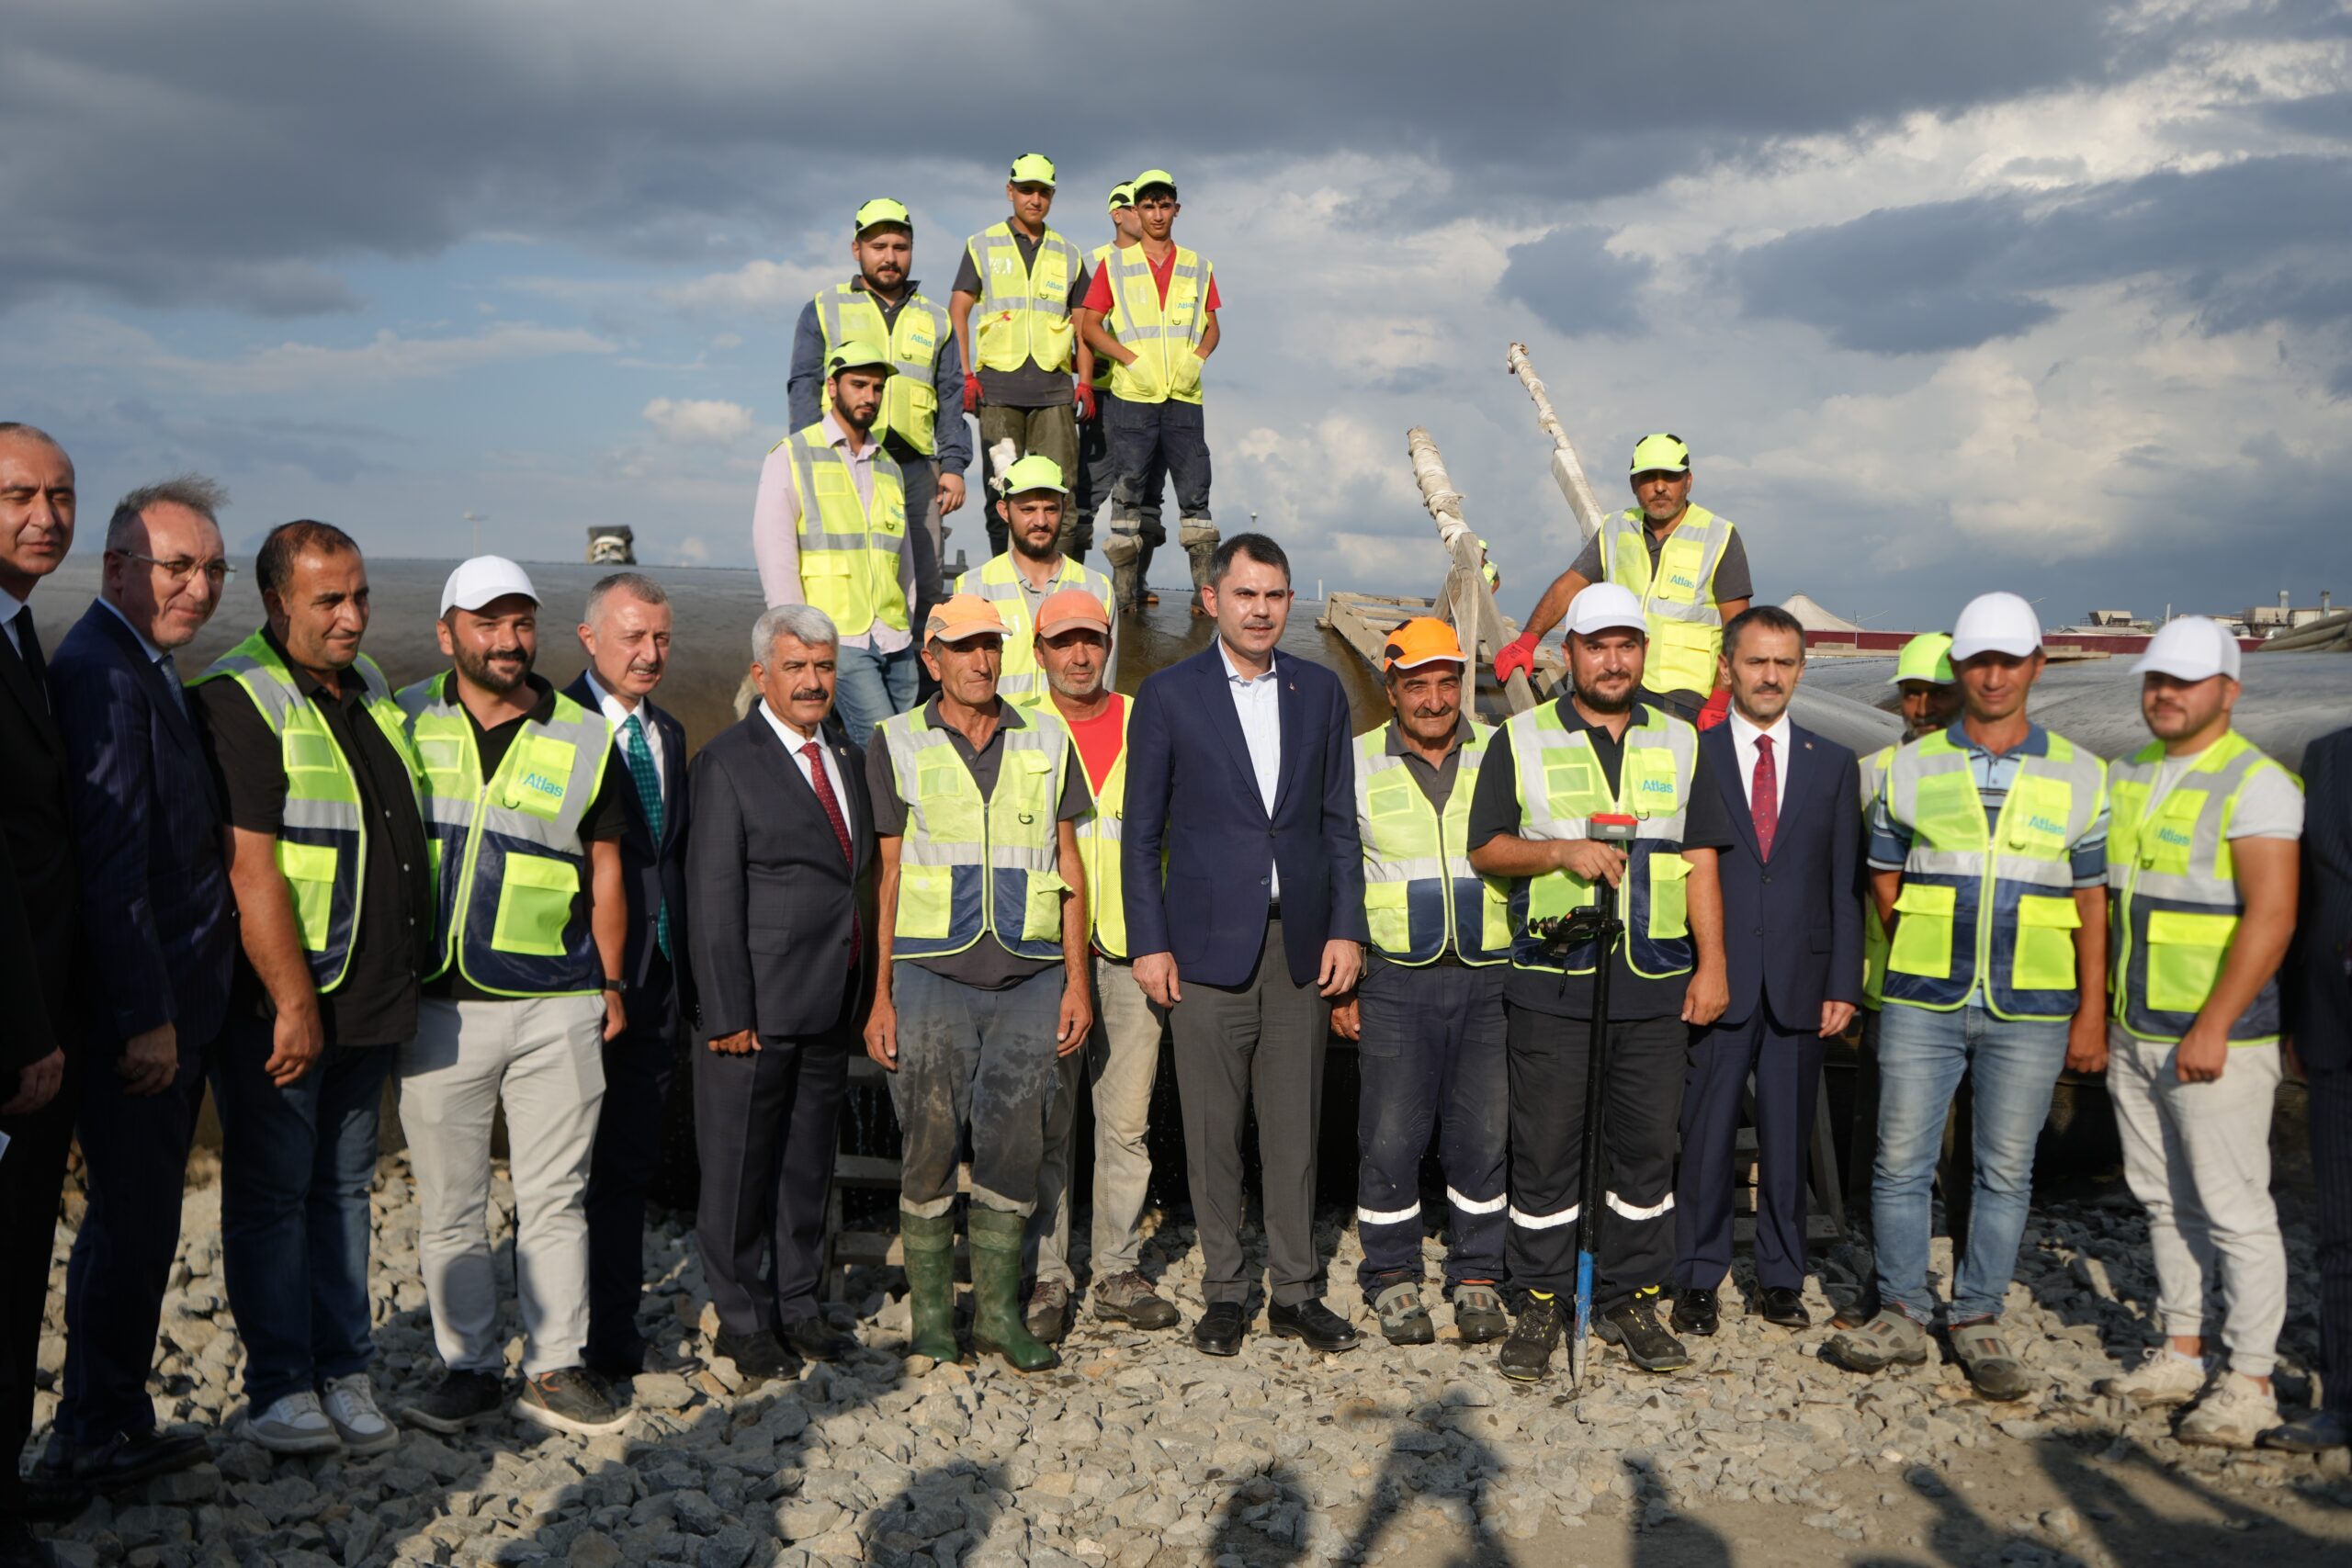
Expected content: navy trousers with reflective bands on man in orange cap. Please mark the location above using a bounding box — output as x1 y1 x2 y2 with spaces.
1355 962 1510 1300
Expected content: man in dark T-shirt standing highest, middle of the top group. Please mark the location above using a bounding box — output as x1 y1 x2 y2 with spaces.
948 152 1087 555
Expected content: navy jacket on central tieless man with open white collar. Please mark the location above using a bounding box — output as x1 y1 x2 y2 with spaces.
1120 642 1371 985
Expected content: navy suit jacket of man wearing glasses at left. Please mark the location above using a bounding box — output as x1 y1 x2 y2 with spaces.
50 602 238 1046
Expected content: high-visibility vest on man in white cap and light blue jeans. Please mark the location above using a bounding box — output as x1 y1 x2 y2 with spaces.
1884 731 2108 1018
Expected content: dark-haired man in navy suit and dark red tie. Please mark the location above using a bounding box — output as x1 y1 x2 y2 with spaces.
1672 604 1863 1336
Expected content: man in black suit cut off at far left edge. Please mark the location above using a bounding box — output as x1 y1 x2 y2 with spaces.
0 423 85 1568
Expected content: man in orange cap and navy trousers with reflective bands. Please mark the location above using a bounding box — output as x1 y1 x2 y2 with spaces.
1331 616 1510 1345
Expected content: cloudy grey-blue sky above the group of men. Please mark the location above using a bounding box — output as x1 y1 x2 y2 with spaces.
0 0 2352 626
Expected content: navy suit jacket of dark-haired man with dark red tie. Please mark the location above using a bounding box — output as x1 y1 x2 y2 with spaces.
1698 722 1863 1032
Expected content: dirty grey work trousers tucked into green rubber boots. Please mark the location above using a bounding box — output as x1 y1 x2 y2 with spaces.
889 964 1063 1218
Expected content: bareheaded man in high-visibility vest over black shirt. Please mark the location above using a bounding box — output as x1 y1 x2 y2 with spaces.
190 520 435 1458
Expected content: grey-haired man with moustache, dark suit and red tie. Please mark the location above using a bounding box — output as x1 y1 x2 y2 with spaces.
687 604 875 1378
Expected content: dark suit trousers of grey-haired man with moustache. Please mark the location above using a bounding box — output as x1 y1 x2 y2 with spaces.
694 997 858 1336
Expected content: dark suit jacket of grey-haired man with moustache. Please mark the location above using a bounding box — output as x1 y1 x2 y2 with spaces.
687 705 875 1042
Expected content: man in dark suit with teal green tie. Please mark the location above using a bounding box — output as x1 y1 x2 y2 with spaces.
564 571 692 1378
